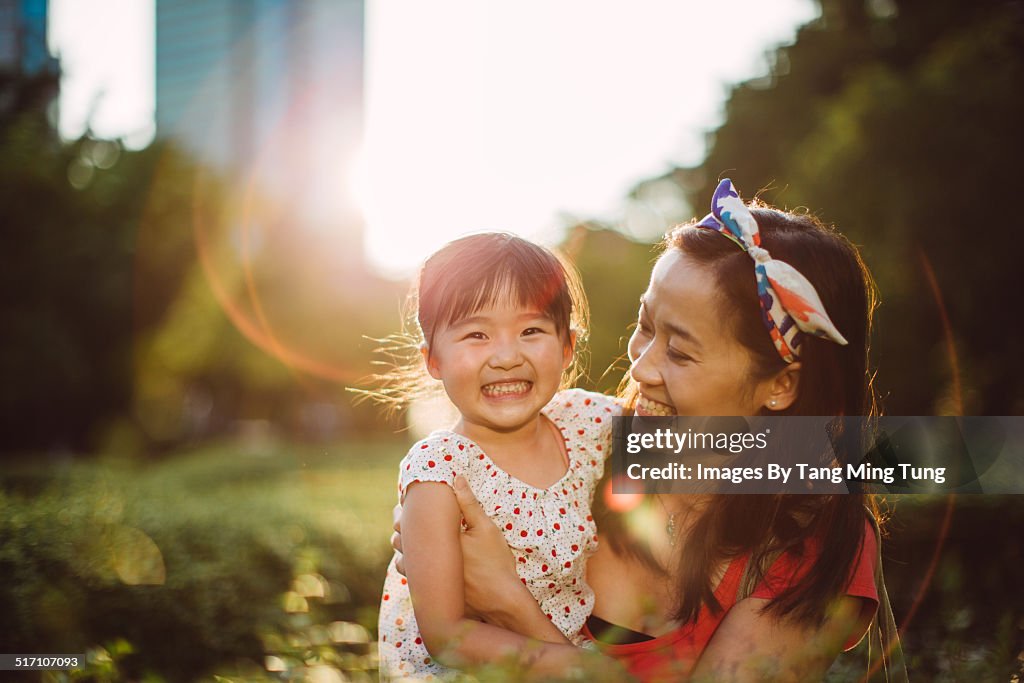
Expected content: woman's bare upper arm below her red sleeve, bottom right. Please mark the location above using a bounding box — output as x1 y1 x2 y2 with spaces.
692 596 870 683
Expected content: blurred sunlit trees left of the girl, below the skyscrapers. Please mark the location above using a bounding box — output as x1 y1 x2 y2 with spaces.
0 97 406 453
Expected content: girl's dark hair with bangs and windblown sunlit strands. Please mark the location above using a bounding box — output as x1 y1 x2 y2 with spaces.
360 232 589 409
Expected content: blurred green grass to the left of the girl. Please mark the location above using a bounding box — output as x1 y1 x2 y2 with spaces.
0 437 409 679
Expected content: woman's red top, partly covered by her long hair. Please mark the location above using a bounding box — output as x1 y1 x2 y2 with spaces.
584 522 879 682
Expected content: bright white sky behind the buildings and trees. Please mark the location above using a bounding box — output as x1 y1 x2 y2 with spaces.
50 0 816 275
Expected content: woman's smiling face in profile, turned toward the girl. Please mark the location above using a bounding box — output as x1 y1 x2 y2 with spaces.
629 249 771 416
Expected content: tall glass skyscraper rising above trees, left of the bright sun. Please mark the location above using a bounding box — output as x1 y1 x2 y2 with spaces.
156 0 364 242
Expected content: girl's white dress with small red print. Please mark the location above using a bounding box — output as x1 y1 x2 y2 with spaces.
378 389 621 680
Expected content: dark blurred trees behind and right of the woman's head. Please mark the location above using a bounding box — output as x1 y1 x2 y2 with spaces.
637 0 1024 415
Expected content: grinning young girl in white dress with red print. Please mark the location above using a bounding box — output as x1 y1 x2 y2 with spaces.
379 233 618 678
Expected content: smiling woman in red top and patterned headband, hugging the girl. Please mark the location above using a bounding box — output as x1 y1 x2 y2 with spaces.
395 180 901 681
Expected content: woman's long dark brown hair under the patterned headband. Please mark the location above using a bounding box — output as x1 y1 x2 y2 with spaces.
595 202 877 624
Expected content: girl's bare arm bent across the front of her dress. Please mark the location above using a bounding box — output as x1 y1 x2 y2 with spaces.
401 482 583 675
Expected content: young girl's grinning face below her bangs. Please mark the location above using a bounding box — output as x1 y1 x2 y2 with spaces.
424 303 572 438
